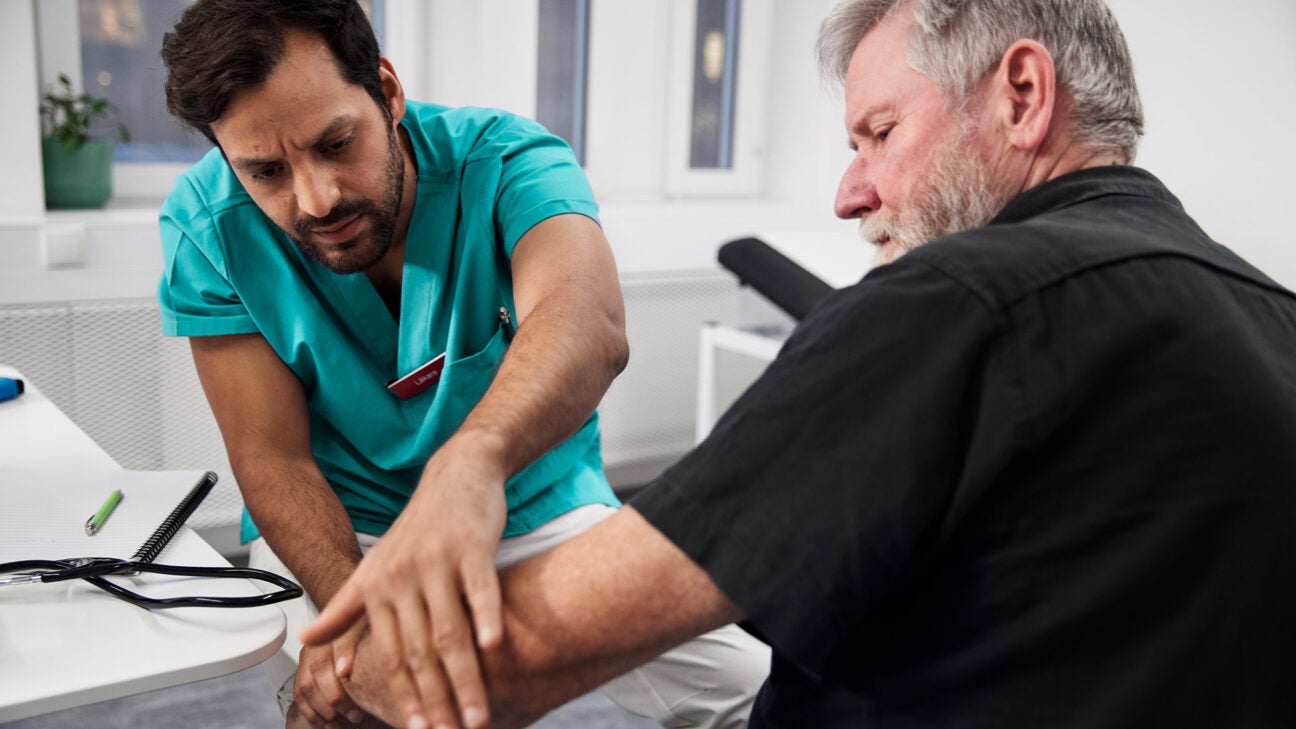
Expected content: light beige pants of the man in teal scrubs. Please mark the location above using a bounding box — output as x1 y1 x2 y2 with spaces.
249 505 770 729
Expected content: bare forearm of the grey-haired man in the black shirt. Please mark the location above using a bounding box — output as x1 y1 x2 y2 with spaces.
483 507 741 726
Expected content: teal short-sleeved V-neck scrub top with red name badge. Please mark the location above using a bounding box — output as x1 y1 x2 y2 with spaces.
158 101 617 541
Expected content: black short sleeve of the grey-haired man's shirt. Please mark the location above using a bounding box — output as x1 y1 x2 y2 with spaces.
630 262 995 676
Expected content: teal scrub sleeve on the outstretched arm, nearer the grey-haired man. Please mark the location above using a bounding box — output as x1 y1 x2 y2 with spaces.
468 110 599 257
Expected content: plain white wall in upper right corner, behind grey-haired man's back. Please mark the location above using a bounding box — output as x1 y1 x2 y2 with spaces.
1108 0 1296 288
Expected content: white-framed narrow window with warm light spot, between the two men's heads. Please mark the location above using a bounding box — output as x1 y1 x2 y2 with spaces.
586 0 774 202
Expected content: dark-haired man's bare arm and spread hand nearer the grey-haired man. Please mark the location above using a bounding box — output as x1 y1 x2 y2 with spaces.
302 214 629 729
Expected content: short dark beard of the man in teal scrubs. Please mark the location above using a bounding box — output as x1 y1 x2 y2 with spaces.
285 115 404 274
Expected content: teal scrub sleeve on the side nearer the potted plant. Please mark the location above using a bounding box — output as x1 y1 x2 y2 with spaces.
158 188 257 336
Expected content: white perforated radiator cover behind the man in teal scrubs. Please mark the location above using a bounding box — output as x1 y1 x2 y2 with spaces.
0 271 739 555
